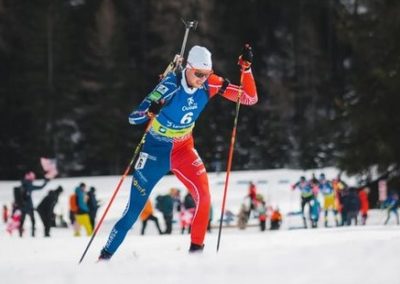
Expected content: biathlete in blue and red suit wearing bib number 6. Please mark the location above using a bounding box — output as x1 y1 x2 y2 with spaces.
99 45 258 259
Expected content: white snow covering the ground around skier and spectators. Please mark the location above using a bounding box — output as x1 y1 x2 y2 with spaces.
0 169 400 284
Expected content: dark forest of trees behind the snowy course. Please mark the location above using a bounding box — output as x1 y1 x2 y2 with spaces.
0 0 400 182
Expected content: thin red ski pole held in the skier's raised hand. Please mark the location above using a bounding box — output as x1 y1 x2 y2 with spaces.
217 68 244 252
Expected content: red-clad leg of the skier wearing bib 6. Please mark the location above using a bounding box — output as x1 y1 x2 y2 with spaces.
171 139 211 246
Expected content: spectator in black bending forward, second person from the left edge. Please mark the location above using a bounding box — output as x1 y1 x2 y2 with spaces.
36 186 63 237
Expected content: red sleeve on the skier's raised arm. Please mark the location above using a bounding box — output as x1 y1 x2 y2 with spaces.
208 69 258 105
